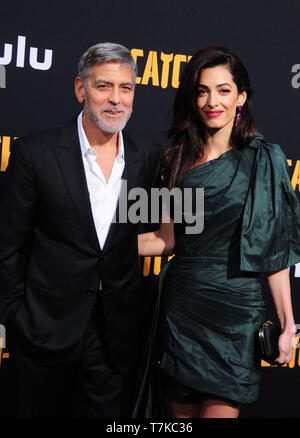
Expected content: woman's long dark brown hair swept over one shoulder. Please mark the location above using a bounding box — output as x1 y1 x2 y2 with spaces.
164 46 256 188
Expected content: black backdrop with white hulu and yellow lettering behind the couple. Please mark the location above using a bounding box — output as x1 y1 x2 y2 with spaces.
0 0 300 418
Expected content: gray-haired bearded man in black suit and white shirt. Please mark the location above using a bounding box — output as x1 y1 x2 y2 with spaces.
0 43 160 417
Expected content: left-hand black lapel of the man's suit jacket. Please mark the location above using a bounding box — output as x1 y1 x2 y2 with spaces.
54 117 101 252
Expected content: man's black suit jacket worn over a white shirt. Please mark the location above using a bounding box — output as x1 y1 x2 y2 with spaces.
0 118 161 373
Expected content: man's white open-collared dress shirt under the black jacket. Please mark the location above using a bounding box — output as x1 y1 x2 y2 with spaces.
77 112 125 249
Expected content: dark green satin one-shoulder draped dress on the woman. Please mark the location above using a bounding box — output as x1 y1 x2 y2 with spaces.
155 134 300 404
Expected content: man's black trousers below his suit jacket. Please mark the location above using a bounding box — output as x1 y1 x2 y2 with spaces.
9 314 135 418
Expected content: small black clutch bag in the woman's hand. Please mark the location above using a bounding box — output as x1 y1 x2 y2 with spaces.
257 321 281 365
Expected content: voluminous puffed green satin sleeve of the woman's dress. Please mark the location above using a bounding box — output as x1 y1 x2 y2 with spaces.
240 137 300 272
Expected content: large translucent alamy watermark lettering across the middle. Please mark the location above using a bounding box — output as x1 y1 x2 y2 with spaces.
112 180 204 234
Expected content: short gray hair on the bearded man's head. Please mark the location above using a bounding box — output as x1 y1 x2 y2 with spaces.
78 43 137 82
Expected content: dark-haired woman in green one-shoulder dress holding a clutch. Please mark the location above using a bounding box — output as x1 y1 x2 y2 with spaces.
139 47 300 418
